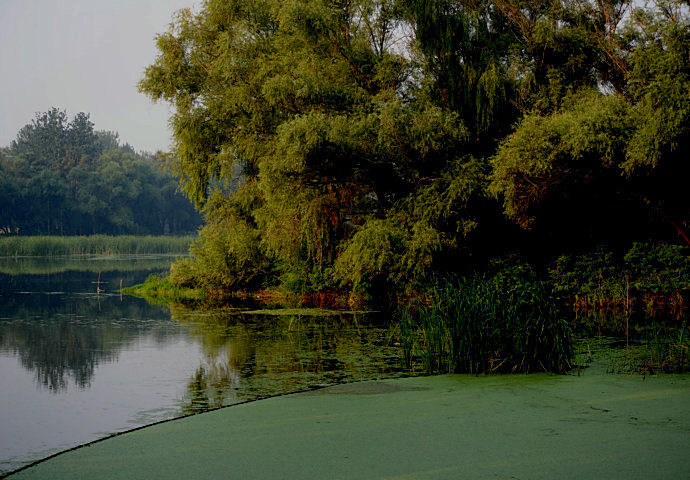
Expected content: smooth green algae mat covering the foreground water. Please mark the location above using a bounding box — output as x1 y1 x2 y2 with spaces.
6 375 690 480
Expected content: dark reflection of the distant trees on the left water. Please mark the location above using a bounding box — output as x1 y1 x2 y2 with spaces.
0 294 177 393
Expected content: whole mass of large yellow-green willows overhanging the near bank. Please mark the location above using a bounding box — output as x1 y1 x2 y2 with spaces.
139 0 690 296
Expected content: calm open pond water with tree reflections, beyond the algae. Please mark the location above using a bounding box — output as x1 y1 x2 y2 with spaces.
0 256 400 474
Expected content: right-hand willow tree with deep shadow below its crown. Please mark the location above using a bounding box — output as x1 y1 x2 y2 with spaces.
492 1 690 251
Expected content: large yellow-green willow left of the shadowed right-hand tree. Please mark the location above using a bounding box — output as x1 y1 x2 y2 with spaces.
139 0 490 288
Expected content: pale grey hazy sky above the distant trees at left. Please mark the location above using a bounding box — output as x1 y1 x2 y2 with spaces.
0 0 200 152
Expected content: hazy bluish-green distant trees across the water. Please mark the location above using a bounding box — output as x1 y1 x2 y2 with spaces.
0 108 201 235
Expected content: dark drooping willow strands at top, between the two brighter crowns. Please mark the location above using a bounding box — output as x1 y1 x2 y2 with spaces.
402 0 518 146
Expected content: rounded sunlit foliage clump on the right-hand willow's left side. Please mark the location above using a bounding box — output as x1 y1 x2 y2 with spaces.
490 91 631 228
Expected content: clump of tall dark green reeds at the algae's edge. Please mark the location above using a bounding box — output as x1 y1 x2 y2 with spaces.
398 270 573 374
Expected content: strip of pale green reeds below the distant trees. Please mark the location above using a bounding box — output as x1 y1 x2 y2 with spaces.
0 235 196 257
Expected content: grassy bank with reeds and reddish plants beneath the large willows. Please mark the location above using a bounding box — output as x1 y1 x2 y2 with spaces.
129 240 690 374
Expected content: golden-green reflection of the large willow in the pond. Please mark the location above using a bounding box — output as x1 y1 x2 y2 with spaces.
173 309 402 414
